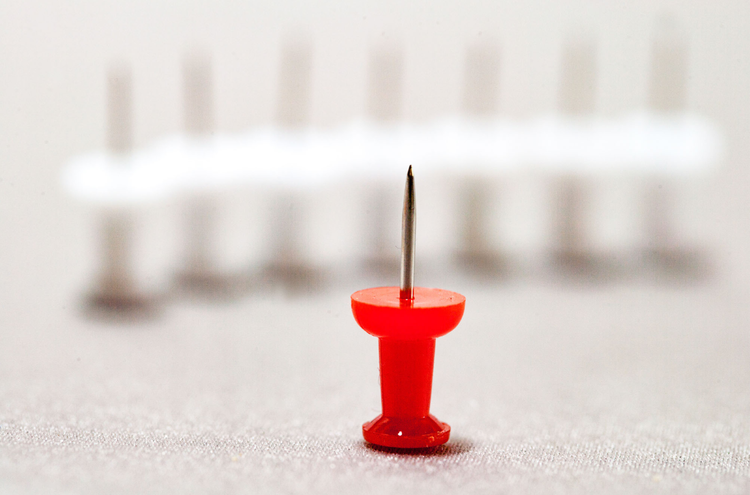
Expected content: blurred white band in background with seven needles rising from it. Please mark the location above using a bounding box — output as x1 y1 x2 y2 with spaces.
63 31 723 204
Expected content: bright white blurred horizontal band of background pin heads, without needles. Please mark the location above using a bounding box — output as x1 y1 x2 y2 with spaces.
63 113 721 204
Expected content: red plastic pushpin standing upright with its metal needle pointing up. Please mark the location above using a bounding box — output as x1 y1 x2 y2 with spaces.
352 166 466 449
